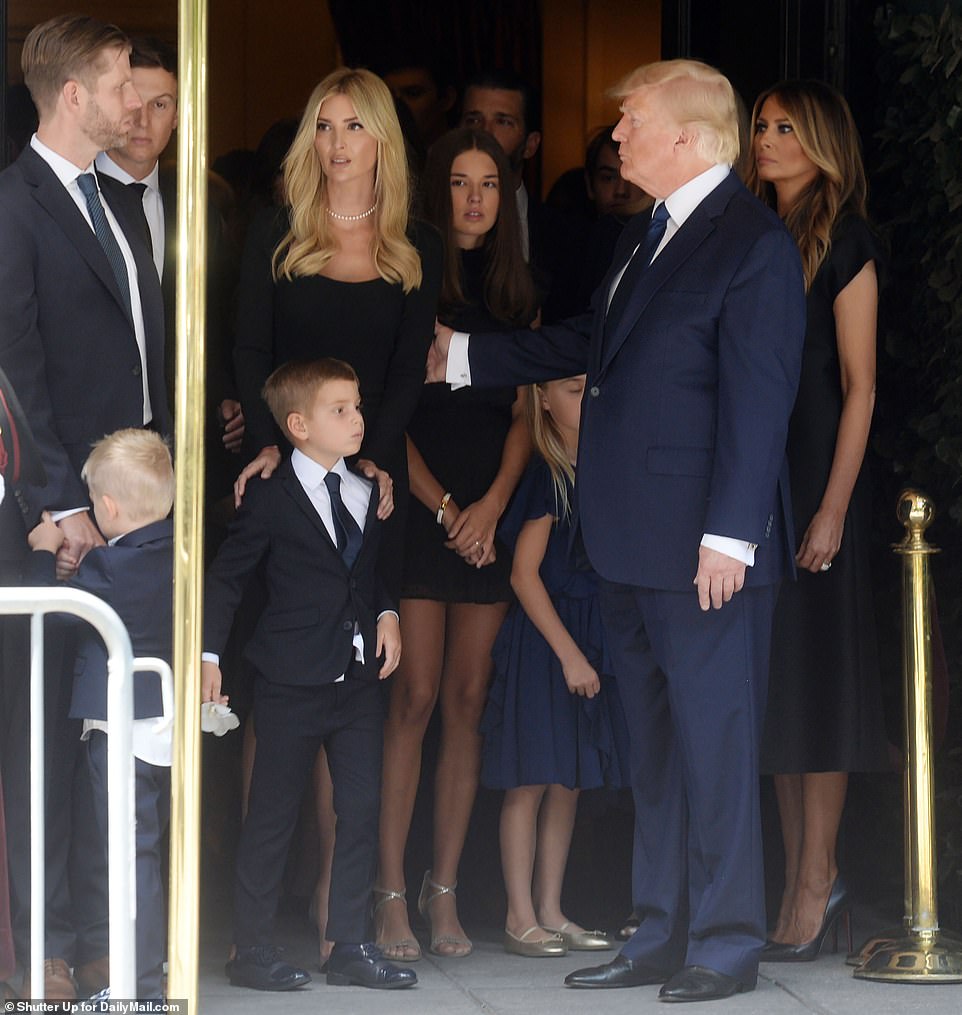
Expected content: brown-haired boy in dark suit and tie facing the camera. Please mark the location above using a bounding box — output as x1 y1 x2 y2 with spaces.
203 359 417 991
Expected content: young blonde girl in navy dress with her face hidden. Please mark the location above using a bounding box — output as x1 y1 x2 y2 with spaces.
481 375 627 957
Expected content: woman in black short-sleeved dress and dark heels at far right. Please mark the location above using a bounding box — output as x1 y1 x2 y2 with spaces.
749 81 886 961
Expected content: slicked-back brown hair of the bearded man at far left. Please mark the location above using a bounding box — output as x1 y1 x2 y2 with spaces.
20 14 130 118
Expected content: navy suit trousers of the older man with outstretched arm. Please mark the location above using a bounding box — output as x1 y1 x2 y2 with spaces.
601 582 776 986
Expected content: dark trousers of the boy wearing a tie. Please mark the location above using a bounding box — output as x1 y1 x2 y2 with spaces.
234 677 384 948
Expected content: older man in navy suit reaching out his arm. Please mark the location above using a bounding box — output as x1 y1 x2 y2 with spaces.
431 61 805 1001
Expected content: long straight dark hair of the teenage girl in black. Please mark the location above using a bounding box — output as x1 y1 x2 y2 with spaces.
424 127 537 325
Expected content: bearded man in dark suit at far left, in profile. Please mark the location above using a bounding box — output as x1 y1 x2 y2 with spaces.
0 15 169 999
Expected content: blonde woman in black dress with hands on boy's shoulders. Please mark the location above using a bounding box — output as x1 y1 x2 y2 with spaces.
234 67 441 961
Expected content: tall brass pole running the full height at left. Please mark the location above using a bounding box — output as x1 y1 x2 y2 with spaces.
167 0 207 1002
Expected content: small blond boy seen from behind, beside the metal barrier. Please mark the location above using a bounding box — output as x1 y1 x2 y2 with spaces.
25 428 174 999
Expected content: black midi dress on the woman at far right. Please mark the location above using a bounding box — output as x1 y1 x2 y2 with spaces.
761 216 888 773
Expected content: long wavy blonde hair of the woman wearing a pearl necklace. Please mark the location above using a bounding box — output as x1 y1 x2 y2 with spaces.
274 67 421 292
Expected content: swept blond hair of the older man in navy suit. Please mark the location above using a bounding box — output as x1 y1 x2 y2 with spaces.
609 60 739 165
